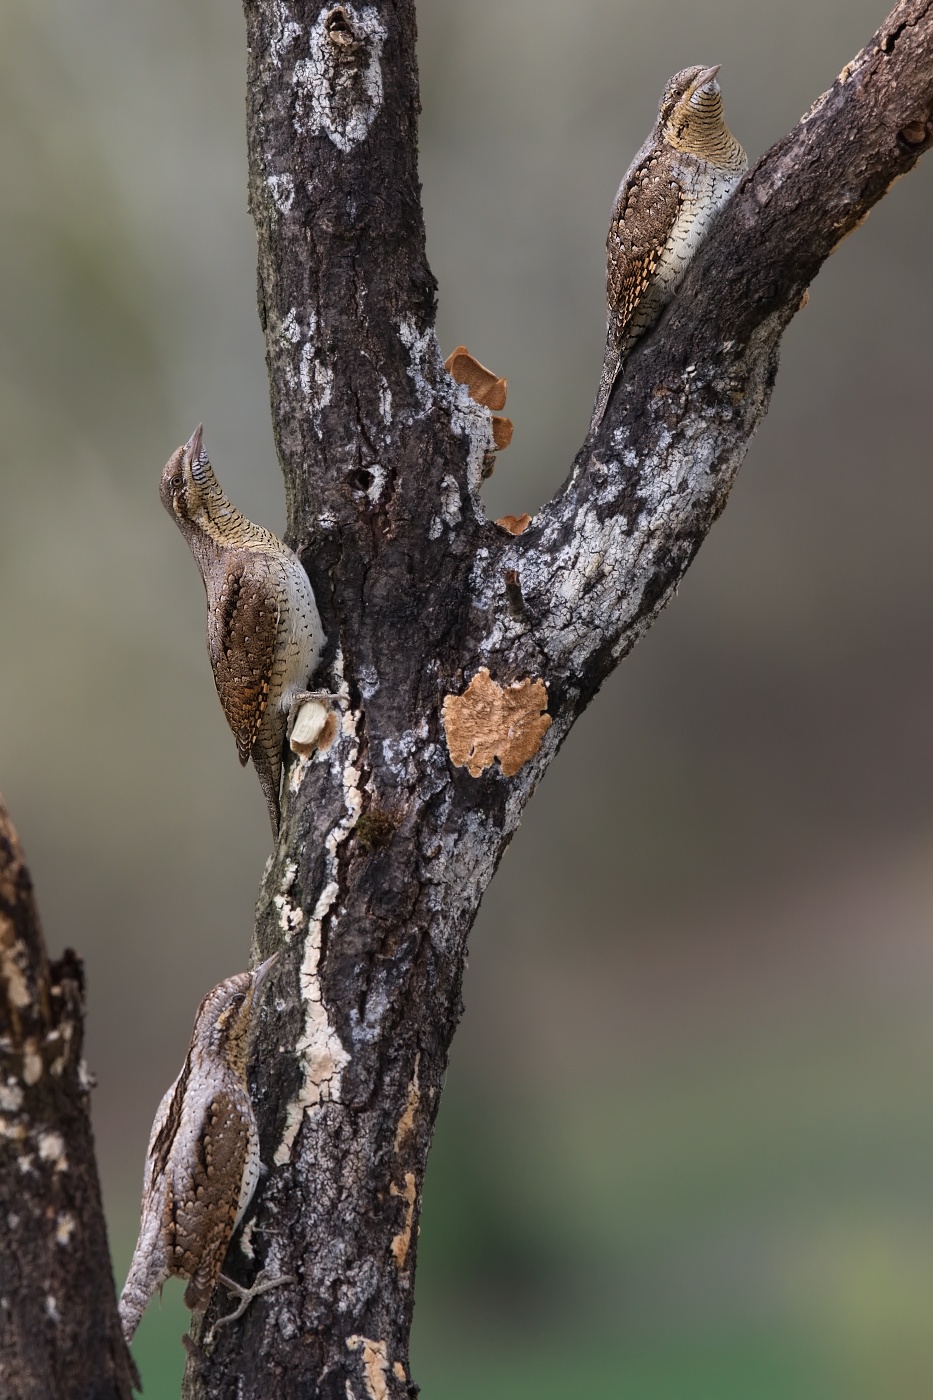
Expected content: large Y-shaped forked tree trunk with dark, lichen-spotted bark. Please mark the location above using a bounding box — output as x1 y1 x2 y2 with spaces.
176 0 933 1400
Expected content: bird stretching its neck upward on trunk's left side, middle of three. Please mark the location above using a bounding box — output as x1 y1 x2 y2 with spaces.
160 426 324 837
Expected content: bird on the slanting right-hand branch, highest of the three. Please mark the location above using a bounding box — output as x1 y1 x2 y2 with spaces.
590 64 748 433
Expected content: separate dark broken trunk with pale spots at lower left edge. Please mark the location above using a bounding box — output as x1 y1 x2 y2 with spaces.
0 801 134 1400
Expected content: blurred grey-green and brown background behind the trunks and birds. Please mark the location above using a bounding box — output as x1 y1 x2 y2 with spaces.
0 0 933 1400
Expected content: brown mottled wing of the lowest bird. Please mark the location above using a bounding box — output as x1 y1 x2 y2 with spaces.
165 1089 249 1308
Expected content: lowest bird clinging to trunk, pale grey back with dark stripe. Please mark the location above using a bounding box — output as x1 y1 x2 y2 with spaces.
120 956 276 1341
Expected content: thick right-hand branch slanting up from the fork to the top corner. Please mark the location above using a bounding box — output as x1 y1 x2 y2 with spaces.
479 0 933 703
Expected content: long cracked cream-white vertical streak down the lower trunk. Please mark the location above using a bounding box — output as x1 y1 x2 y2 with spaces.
275 700 363 1165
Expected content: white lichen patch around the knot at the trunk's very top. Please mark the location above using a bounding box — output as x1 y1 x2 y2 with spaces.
294 4 385 153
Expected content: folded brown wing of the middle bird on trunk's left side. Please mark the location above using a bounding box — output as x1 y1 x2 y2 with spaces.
207 561 280 763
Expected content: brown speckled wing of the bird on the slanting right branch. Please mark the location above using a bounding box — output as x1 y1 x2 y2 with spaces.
607 155 684 349
